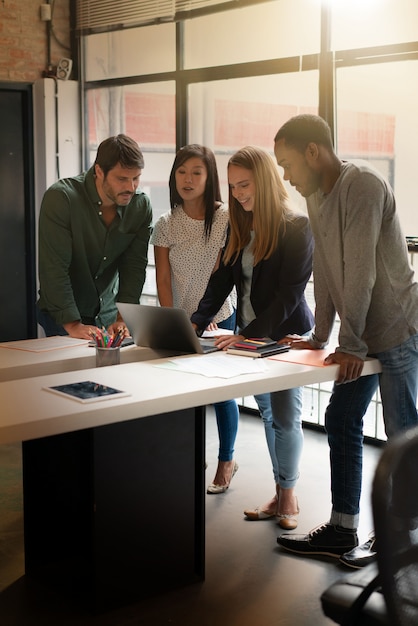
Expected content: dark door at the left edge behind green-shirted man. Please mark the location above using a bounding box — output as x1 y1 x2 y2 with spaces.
0 83 36 341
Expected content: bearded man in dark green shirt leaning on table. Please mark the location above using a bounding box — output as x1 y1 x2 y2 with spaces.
37 135 152 339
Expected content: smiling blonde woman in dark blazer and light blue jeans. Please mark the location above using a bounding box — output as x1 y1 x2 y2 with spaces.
191 146 313 530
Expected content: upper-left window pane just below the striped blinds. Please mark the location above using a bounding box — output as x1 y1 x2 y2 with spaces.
83 24 176 81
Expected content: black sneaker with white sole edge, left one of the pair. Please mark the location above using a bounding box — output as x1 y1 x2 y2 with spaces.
277 524 358 558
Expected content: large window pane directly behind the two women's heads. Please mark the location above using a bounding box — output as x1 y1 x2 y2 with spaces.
189 71 318 211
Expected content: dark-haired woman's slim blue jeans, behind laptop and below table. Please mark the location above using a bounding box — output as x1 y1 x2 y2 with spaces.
213 313 239 461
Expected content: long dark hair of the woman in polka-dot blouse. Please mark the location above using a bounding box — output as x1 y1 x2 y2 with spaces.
169 143 222 239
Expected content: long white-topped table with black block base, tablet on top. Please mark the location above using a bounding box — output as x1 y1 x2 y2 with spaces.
0 347 380 609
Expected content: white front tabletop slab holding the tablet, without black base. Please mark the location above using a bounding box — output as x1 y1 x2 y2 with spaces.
0 348 380 444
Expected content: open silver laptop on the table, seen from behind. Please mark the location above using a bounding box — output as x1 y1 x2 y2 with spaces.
117 302 218 354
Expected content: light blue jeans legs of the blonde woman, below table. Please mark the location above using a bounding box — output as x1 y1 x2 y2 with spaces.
254 387 303 489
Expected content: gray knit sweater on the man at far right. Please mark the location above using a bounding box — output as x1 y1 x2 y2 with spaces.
307 162 418 358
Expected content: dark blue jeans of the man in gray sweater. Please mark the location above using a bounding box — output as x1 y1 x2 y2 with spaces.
325 334 418 528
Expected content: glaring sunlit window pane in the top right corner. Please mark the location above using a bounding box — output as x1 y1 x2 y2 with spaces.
332 0 418 50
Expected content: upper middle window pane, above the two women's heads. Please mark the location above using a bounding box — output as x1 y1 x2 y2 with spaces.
185 0 320 68
